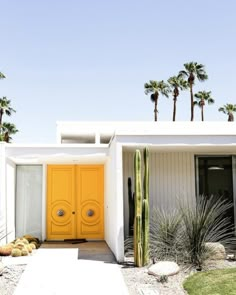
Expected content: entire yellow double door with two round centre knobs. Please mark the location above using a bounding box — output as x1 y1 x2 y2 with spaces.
47 165 104 240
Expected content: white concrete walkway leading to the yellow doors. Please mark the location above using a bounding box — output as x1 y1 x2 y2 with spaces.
14 243 128 295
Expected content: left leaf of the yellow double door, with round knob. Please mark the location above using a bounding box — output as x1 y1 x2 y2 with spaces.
47 165 76 240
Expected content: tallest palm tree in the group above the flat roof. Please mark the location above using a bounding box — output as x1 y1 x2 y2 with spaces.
179 62 208 121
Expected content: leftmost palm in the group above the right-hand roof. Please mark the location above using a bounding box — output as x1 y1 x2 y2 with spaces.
144 80 170 121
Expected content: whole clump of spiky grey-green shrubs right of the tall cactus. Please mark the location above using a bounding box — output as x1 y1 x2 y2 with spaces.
150 196 235 270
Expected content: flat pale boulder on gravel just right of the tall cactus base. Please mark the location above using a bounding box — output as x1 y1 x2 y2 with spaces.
148 261 180 276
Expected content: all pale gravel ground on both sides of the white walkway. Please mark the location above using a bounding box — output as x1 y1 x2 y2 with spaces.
0 260 236 295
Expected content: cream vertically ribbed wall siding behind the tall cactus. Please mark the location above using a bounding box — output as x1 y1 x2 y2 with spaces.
123 151 195 236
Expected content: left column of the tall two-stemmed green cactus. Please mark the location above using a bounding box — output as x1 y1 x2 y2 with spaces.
134 150 143 266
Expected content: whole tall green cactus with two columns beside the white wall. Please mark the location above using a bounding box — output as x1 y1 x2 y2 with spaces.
134 148 149 266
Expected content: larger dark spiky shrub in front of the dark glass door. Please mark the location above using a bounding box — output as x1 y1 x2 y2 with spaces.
180 196 235 269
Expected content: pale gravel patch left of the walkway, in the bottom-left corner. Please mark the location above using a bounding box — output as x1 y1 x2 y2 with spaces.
0 264 26 295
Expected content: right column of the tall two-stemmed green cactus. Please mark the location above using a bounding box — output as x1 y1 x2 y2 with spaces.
142 148 149 265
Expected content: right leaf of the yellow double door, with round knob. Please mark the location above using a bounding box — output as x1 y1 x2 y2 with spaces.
76 165 104 239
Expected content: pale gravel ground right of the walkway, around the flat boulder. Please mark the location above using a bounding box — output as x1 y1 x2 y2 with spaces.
121 260 236 295
